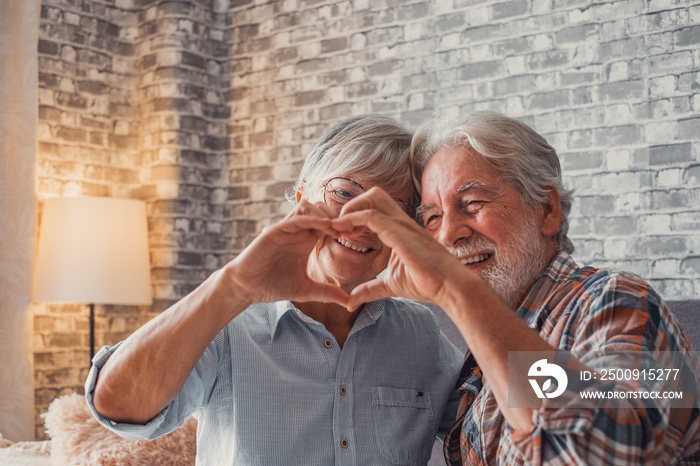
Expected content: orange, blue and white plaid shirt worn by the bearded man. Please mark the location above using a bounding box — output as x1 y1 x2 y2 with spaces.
444 253 700 465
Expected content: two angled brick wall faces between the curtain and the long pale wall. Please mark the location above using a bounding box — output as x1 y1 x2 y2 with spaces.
35 0 235 438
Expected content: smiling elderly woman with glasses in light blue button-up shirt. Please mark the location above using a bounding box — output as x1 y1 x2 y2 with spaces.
86 115 462 466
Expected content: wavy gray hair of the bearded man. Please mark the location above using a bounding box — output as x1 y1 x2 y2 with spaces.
411 112 574 253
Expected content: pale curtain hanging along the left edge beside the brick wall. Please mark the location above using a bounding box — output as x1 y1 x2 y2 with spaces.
0 0 41 442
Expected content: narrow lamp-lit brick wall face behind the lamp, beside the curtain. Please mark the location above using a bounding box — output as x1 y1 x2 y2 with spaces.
34 1 143 438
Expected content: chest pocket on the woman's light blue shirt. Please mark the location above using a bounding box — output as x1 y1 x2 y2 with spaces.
372 387 435 465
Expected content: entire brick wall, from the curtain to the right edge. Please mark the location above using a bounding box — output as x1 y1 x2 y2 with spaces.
35 0 700 436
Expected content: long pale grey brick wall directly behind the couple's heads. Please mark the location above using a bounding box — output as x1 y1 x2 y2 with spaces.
224 0 700 299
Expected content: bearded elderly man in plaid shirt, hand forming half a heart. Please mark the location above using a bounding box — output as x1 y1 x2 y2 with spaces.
332 113 700 465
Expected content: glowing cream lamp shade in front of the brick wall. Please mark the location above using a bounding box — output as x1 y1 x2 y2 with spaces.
34 197 152 304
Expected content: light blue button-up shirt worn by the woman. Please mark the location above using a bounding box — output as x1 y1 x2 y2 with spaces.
85 299 463 466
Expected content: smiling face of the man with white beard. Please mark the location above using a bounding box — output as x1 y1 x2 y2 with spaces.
418 147 551 308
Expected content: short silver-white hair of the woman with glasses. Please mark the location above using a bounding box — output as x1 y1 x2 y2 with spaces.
286 114 419 207
